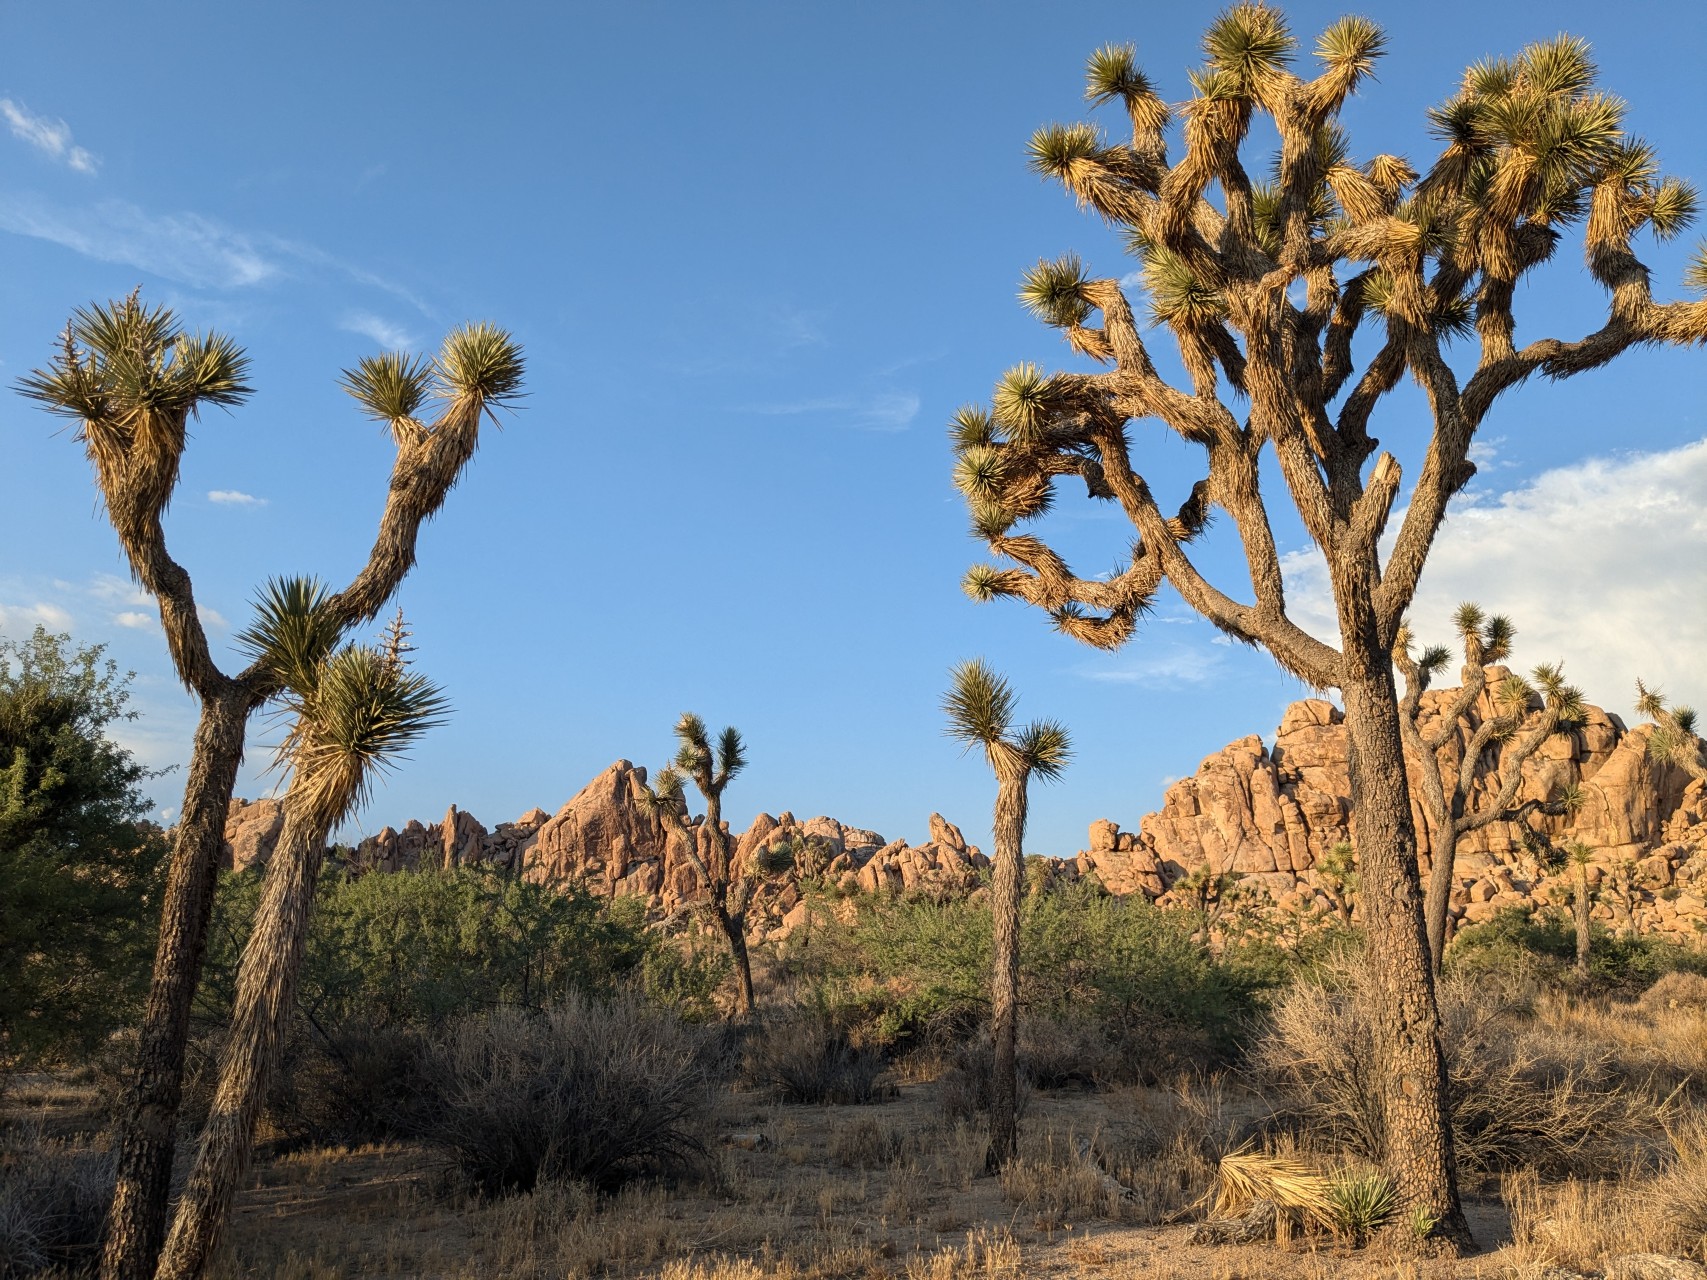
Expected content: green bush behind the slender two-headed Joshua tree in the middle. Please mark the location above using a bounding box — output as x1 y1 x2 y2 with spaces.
804 884 1258 1079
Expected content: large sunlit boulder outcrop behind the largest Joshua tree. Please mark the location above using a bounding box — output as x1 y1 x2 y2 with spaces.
1106 686 1707 937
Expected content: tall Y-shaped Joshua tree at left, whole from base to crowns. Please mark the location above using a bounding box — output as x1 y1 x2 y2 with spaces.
20 294 522 1280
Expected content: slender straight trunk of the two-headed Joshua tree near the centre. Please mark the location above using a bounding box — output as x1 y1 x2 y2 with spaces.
985 773 1026 1172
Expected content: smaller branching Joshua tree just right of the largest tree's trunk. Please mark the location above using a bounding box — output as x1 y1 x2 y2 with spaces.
1393 602 1582 973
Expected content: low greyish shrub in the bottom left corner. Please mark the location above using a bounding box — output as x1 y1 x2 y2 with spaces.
0 1126 113 1280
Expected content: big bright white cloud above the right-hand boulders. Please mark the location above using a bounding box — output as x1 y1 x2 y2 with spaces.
1282 440 1707 713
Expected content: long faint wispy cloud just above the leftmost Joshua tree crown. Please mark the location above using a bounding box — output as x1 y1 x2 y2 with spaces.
0 195 282 288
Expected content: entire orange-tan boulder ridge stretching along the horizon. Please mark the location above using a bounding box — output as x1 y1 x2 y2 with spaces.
225 667 1707 942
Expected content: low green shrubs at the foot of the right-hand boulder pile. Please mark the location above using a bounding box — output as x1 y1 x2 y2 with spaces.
1444 906 1707 990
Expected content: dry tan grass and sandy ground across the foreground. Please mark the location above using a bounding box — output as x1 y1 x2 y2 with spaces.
7 983 1707 1280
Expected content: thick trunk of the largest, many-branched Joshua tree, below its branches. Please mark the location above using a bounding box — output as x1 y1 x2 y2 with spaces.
1342 665 1470 1246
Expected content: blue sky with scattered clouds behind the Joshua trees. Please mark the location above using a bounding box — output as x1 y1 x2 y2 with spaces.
0 0 1707 853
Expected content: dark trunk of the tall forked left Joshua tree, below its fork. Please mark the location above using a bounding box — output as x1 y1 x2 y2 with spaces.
101 681 254 1280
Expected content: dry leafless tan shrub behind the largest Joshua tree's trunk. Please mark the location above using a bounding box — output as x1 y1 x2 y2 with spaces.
1253 957 1640 1171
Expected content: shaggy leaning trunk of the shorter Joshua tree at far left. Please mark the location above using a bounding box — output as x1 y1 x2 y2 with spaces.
155 812 329 1280
